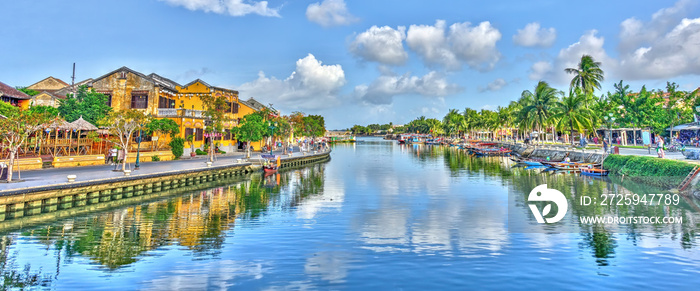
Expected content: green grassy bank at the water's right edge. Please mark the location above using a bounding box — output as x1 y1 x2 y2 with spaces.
603 155 694 188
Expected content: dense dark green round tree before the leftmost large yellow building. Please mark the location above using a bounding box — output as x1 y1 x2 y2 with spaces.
58 86 112 124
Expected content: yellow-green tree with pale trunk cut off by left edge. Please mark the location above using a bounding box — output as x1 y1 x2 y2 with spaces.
0 110 52 182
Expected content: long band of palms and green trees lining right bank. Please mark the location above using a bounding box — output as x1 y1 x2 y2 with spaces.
351 55 700 145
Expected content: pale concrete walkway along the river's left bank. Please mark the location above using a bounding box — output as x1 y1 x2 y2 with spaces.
0 147 326 193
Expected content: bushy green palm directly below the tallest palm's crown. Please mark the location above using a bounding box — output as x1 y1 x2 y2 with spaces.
550 90 593 145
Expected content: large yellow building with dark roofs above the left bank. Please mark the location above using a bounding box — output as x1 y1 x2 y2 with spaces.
77 67 279 156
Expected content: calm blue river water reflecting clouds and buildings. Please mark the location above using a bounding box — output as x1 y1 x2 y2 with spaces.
0 139 700 290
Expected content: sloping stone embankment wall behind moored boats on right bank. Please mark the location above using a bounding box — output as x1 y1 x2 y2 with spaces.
500 143 603 164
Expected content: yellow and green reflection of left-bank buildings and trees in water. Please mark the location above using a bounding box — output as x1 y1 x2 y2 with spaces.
0 165 330 269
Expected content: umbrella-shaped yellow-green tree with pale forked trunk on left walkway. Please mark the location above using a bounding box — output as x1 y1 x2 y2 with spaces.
98 109 149 171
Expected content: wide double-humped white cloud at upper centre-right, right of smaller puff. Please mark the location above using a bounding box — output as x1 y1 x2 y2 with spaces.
406 20 501 71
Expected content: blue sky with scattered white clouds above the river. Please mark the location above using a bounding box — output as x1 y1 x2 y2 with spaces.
0 0 700 129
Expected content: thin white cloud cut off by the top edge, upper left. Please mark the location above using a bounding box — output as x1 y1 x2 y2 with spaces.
160 0 280 17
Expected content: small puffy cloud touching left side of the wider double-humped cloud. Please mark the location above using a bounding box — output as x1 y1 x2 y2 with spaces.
350 26 408 65
